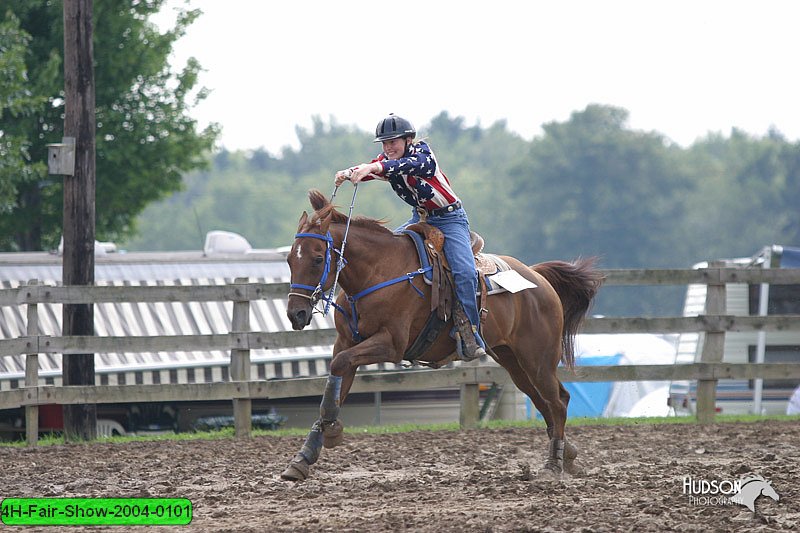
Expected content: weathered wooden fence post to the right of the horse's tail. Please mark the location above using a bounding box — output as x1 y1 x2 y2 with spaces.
697 261 726 424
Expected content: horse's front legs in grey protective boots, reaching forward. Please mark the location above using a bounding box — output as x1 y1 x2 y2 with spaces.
281 329 396 481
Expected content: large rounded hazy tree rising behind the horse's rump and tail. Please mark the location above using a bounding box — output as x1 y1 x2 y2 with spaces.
509 105 692 315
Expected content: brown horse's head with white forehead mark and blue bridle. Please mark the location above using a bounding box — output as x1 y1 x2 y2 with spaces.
286 190 335 330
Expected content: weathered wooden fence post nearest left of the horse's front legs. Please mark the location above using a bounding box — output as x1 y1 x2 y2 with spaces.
230 278 253 437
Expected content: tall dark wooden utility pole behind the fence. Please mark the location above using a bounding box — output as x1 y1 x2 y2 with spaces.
62 0 97 441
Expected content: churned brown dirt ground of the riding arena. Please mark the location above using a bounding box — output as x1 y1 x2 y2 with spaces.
0 421 800 533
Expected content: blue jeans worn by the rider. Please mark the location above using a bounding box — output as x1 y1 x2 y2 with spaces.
397 208 486 348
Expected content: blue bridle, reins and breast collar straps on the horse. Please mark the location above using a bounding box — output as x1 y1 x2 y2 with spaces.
289 231 433 342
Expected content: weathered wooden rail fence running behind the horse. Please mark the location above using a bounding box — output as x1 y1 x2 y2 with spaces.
0 268 800 444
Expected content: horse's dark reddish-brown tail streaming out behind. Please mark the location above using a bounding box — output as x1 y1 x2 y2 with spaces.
529 257 604 368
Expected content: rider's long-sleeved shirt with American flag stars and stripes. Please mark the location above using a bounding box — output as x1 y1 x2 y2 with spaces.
364 141 458 210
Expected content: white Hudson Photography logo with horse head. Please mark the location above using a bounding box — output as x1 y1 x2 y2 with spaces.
683 476 780 512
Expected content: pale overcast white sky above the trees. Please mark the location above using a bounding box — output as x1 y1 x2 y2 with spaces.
157 0 800 153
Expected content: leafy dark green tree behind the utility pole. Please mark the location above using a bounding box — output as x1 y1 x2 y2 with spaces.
0 0 218 250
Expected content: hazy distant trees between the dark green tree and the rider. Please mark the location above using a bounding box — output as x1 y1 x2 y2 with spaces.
121 117 399 250
